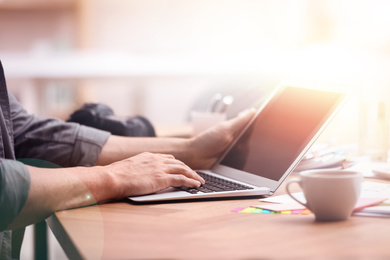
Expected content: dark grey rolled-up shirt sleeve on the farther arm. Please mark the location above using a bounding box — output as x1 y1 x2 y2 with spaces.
10 94 110 167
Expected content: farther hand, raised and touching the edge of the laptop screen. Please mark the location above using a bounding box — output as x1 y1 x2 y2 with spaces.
186 109 256 169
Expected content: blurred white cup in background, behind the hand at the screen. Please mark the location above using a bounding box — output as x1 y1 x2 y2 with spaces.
191 111 226 135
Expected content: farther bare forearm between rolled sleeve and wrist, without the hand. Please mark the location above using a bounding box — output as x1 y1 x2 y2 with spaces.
97 135 192 166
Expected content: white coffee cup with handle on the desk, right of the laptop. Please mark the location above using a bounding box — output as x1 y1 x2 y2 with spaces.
286 170 363 221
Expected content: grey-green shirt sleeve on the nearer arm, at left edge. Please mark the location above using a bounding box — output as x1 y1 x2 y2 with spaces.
0 160 31 231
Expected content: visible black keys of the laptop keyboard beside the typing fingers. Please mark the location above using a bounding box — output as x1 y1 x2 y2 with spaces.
181 172 253 194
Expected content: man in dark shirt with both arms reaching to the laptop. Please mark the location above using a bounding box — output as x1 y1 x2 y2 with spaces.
0 60 253 259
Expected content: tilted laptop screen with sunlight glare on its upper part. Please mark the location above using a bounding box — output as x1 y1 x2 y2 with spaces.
220 87 345 181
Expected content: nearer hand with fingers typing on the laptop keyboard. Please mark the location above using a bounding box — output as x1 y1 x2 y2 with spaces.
104 152 204 199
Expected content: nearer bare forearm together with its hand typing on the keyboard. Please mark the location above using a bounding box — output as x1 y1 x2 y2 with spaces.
8 153 204 229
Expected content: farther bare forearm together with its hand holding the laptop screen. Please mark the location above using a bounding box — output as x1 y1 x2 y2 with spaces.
97 110 255 169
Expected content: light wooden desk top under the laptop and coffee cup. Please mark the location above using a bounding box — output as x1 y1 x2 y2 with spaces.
47 179 390 259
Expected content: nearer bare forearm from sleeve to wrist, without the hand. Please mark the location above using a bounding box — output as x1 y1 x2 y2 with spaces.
9 166 115 229
